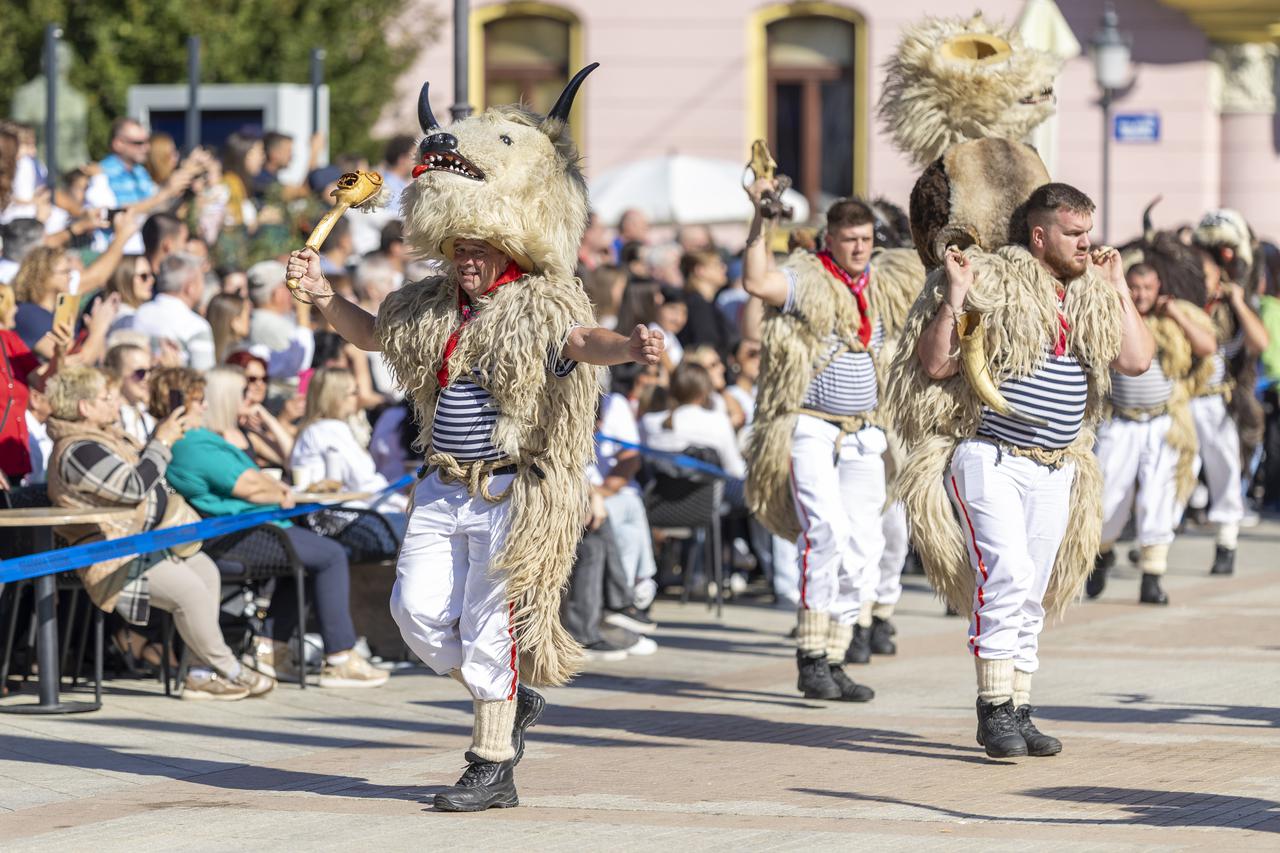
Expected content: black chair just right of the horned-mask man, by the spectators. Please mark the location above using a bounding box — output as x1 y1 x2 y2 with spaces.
644 446 724 617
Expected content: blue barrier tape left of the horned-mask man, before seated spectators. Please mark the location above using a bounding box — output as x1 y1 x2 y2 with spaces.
0 474 413 584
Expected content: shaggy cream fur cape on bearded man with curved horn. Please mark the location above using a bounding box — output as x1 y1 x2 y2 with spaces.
884 246 1121 616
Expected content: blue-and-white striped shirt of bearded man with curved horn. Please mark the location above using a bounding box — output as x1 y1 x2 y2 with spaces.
978 350 1089 450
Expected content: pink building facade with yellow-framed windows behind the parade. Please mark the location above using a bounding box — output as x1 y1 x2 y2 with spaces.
376 0 1280 241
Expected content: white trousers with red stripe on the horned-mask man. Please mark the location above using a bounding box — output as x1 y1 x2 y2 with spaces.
390 474 520 701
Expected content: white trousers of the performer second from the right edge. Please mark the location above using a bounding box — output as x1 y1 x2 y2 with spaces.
1093 415 1178 547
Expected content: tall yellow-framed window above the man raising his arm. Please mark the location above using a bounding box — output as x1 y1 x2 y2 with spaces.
765 15 863 204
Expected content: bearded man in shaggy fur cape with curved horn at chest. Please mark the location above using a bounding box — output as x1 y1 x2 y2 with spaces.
887 183 1152 757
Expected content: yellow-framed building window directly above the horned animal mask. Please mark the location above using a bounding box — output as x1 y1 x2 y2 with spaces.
484 15 570 111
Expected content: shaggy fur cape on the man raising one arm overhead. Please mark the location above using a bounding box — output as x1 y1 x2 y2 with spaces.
746 248 924 539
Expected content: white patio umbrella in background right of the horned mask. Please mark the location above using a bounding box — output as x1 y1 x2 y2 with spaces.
588 154 809 225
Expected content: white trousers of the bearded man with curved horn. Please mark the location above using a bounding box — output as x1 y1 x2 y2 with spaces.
946 442 1075 672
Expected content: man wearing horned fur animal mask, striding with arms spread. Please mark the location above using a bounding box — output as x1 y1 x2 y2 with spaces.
289 65 662 811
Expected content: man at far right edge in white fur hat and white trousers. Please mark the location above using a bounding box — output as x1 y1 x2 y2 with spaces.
1192 210 1267 575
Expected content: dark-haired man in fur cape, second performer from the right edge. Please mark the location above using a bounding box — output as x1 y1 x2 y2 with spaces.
1085 249 1217 605
